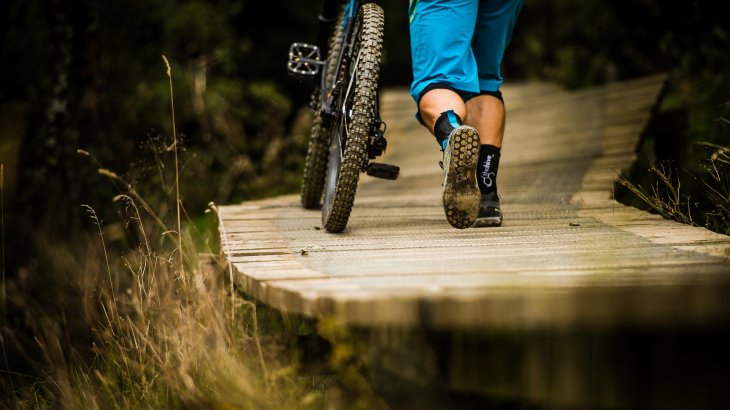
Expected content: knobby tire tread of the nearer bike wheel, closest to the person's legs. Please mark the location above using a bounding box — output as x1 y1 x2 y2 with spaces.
322 3 384 232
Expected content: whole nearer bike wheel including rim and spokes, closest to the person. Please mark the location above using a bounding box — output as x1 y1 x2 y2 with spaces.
322 3 384 232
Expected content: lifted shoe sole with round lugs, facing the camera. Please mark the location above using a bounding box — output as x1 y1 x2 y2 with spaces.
443 127 481 229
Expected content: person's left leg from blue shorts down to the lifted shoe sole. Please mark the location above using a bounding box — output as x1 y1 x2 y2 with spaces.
409 0 480 229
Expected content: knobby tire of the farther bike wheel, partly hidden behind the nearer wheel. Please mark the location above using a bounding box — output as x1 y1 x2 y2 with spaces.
300 9 344 209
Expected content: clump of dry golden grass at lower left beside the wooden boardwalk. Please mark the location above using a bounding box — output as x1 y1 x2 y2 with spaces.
3 171 314 409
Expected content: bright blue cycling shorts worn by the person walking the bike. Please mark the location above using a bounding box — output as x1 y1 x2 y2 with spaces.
408 0 523 103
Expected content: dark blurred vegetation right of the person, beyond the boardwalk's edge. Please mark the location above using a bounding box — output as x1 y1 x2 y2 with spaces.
505 0 730 233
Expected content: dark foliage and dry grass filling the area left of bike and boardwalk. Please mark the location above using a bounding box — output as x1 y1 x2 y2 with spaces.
0 0 407 408
